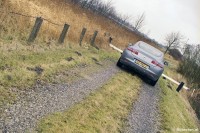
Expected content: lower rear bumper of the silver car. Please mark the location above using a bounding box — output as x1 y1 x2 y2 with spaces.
120 57 161 81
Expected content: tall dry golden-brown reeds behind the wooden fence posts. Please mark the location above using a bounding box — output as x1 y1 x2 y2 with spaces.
0 0 155 48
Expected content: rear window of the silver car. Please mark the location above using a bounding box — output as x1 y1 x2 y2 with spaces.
138 42 163 57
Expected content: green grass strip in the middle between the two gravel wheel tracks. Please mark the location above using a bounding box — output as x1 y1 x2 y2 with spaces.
37 72 141 133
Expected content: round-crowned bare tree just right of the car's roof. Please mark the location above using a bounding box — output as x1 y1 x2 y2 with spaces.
165 32 184 54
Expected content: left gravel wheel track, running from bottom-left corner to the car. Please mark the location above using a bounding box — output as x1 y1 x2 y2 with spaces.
0 63 119 133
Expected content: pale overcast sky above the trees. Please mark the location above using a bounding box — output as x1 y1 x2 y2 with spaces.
103 0 200 44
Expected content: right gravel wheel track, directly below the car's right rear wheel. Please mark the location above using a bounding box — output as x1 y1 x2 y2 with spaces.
125 83 160 133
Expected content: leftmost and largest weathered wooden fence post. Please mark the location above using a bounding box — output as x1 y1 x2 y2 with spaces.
28 17 43 42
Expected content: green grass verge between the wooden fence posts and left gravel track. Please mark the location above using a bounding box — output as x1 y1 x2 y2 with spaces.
0 44 119 110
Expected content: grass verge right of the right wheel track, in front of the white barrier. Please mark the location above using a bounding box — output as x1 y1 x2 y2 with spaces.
160 79 198 133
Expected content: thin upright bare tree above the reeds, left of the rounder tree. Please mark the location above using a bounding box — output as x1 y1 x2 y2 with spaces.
133 13 145 30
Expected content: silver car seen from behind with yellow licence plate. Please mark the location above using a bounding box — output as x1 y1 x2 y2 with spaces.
117 41 164 86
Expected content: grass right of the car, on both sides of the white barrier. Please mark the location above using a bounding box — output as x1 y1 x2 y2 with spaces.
159 55 200 133
